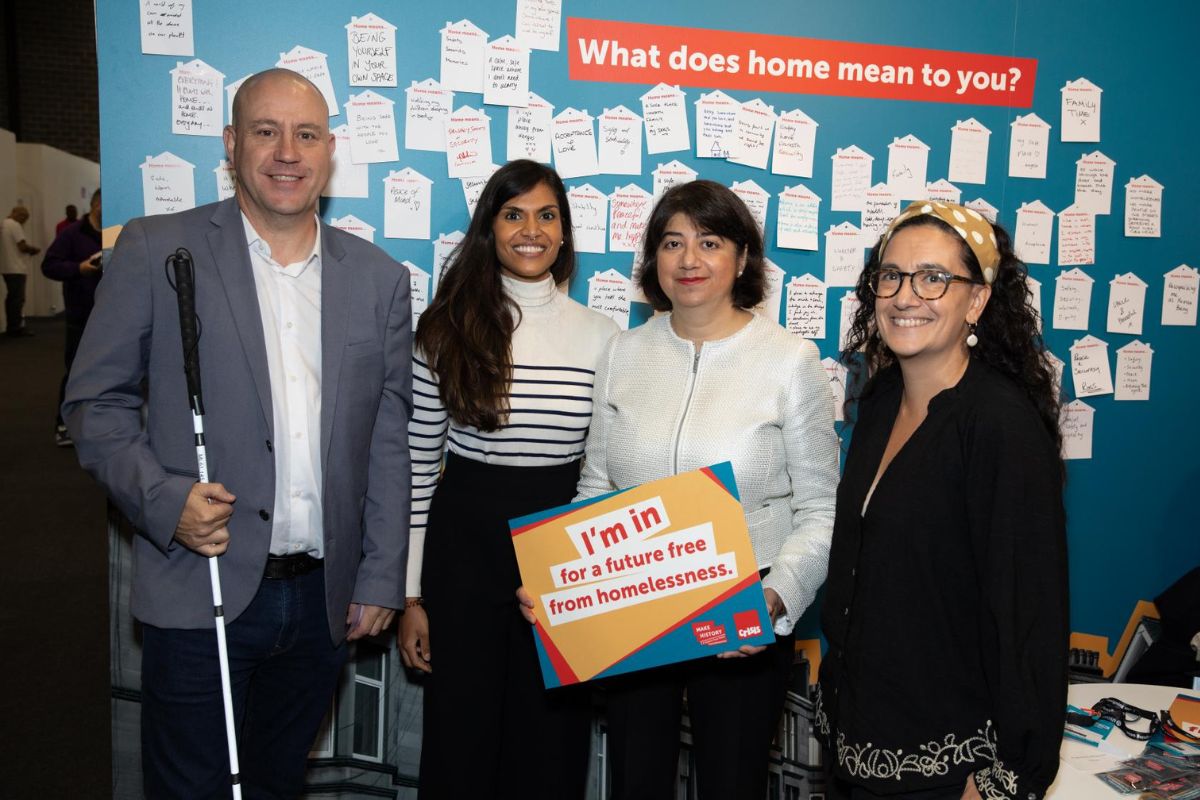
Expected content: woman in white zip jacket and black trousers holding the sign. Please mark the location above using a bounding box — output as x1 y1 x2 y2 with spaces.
544 181 838 800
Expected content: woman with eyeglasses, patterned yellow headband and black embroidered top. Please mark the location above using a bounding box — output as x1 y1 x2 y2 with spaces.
816 201 1068 800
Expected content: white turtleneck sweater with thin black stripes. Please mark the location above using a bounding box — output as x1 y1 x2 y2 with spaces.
406 275 618 596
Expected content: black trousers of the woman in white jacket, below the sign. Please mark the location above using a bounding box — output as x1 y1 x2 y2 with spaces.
605 634 796 800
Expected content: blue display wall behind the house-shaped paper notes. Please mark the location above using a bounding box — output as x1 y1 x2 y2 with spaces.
97 0 1200 639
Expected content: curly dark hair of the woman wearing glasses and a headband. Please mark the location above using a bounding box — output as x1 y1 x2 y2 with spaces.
841 215 1062 463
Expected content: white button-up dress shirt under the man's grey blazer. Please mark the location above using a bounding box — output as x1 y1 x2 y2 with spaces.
241 215 325 558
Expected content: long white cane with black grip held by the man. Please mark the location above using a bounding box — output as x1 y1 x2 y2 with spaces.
167 247 241 800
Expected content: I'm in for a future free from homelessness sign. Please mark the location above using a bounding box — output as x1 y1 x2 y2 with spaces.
509 462 775 688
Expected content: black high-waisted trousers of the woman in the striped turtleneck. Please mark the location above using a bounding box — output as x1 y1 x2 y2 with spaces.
418 455 592 800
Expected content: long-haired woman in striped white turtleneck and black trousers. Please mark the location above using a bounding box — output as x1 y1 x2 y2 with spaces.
400 161 617 800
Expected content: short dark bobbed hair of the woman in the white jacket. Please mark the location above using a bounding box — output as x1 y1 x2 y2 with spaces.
638 180 767 311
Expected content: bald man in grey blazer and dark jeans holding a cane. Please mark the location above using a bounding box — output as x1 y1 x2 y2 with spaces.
64 70 412 798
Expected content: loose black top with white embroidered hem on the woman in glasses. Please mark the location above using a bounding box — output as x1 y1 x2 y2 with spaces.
816 359 1068 800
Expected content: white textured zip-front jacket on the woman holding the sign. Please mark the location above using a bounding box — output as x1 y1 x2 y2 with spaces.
576 314 838 636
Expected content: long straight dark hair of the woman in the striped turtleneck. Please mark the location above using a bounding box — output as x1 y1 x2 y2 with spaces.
415 160 575 431
